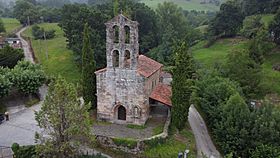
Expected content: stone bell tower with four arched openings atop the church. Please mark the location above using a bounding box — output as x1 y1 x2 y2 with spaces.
105 14 139 70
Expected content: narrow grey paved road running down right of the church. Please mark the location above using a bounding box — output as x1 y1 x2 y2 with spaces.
189 105 221 158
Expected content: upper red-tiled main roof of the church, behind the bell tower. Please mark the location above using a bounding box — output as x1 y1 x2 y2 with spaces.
95 55 163 78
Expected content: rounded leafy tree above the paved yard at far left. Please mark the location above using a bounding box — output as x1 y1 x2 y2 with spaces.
11 61 46 94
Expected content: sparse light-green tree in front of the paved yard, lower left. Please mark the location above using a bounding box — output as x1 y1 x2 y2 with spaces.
35 77 92 158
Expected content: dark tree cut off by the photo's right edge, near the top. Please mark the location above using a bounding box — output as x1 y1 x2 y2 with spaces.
269 9 280 45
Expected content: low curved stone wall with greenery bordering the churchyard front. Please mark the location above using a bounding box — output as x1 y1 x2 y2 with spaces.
96 110 171 154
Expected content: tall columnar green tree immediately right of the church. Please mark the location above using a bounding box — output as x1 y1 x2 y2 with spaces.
171 42 195 130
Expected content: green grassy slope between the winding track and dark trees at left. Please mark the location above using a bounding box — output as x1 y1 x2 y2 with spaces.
24 23 81 83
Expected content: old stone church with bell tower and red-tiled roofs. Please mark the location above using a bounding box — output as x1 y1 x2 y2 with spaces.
95 14 171 125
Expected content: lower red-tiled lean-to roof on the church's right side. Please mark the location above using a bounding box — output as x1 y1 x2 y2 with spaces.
150 83 172 107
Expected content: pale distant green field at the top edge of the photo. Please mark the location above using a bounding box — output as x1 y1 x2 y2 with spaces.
140 0 220 11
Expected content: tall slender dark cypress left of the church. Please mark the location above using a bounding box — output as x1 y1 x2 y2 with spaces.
82 24 97 108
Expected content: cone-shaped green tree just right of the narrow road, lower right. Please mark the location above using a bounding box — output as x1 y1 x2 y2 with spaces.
213 93 252 157
